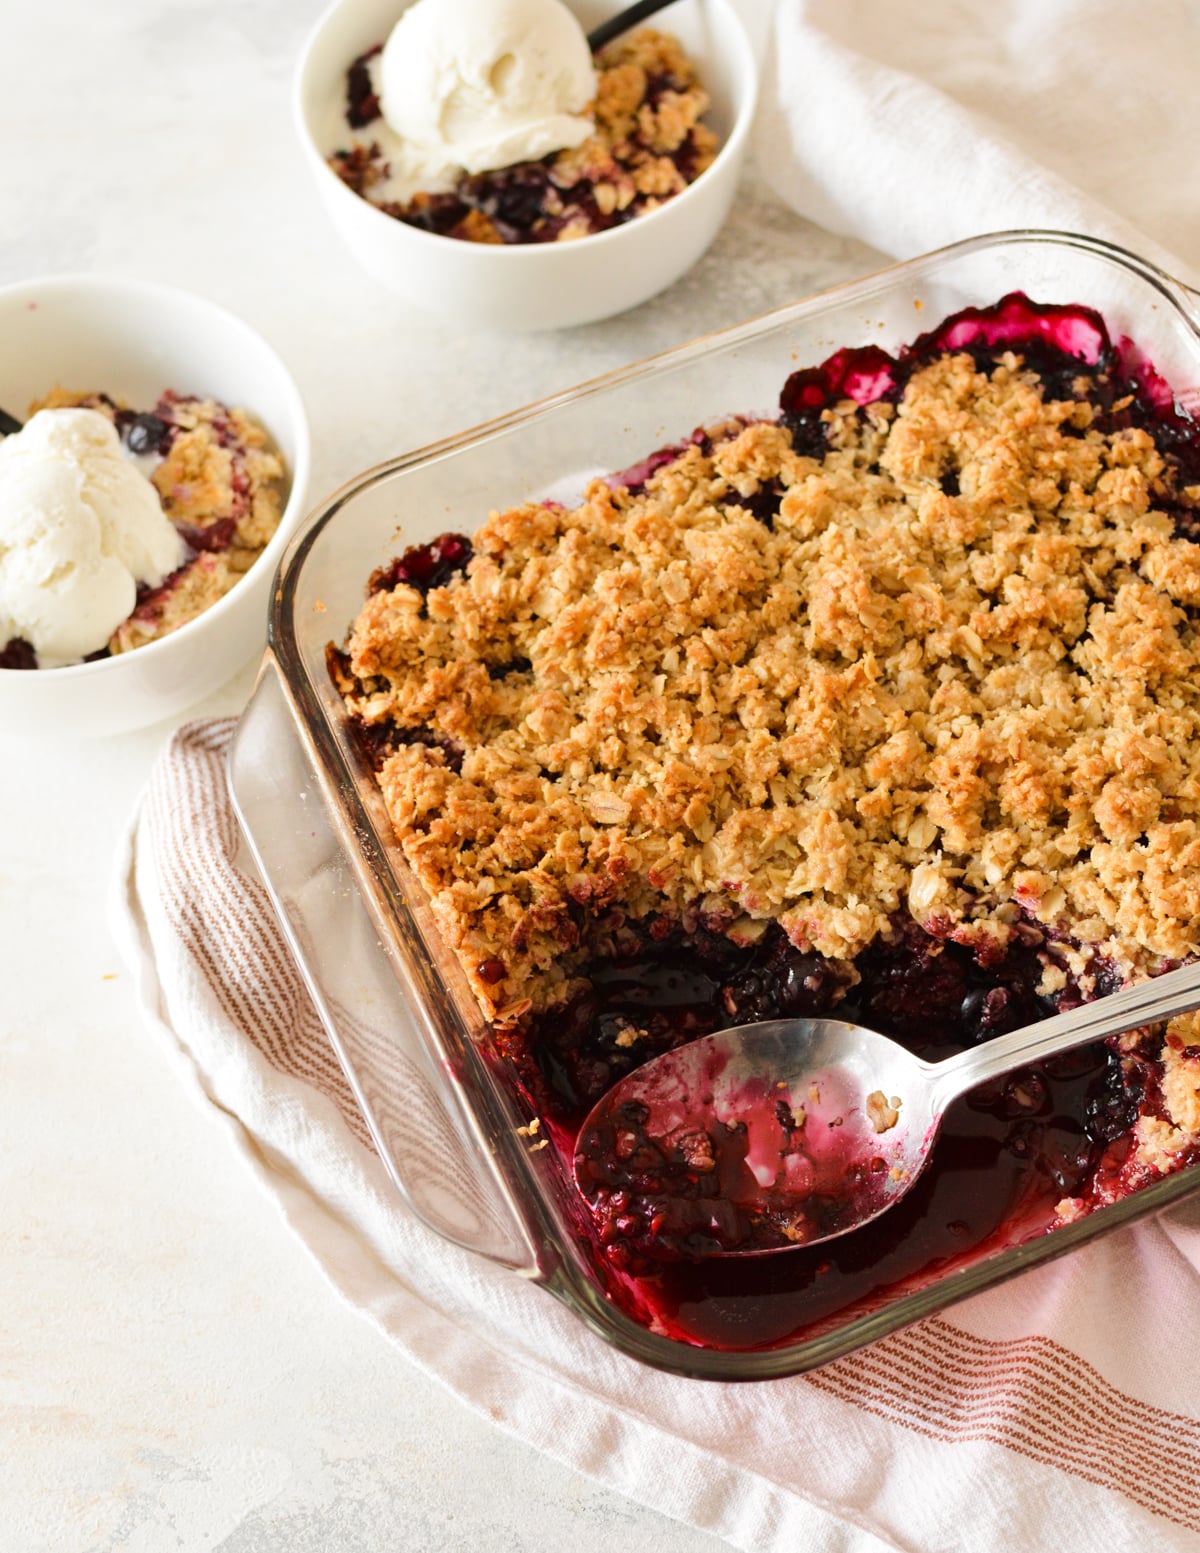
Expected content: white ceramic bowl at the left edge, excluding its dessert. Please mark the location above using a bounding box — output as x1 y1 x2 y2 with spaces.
0 275 309 735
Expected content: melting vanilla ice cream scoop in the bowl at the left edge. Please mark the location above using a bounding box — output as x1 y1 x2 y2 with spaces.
0 410 186 668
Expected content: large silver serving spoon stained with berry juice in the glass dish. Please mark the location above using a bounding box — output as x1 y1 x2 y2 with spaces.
574 964 1200 1256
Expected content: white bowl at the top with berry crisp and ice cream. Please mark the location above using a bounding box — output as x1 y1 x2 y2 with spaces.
293 0 756 331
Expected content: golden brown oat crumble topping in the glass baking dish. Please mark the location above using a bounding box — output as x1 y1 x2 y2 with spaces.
332 356 1200 1037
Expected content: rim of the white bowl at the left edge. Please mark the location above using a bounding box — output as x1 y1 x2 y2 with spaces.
0 270 310 682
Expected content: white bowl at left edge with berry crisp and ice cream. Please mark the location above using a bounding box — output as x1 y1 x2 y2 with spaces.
0 276 309 735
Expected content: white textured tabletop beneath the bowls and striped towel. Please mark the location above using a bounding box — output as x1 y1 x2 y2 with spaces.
0 0 872 1553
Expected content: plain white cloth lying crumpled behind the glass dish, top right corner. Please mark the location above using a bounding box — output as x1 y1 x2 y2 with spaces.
756 0 1200 280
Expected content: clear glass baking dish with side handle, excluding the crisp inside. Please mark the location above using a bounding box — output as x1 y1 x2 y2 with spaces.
231 231 1200 1381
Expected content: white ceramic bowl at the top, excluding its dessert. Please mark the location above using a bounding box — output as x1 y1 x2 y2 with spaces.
293 0 758 329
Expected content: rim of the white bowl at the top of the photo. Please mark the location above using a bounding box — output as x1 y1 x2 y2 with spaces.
292 0 759 264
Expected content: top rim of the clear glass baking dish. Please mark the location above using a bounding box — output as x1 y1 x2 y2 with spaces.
257 228 1200 1381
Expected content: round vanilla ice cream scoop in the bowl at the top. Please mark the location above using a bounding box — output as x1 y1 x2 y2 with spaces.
379 0 596 181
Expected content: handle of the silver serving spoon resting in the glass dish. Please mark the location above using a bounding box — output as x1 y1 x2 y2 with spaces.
925 963 1200 1117
